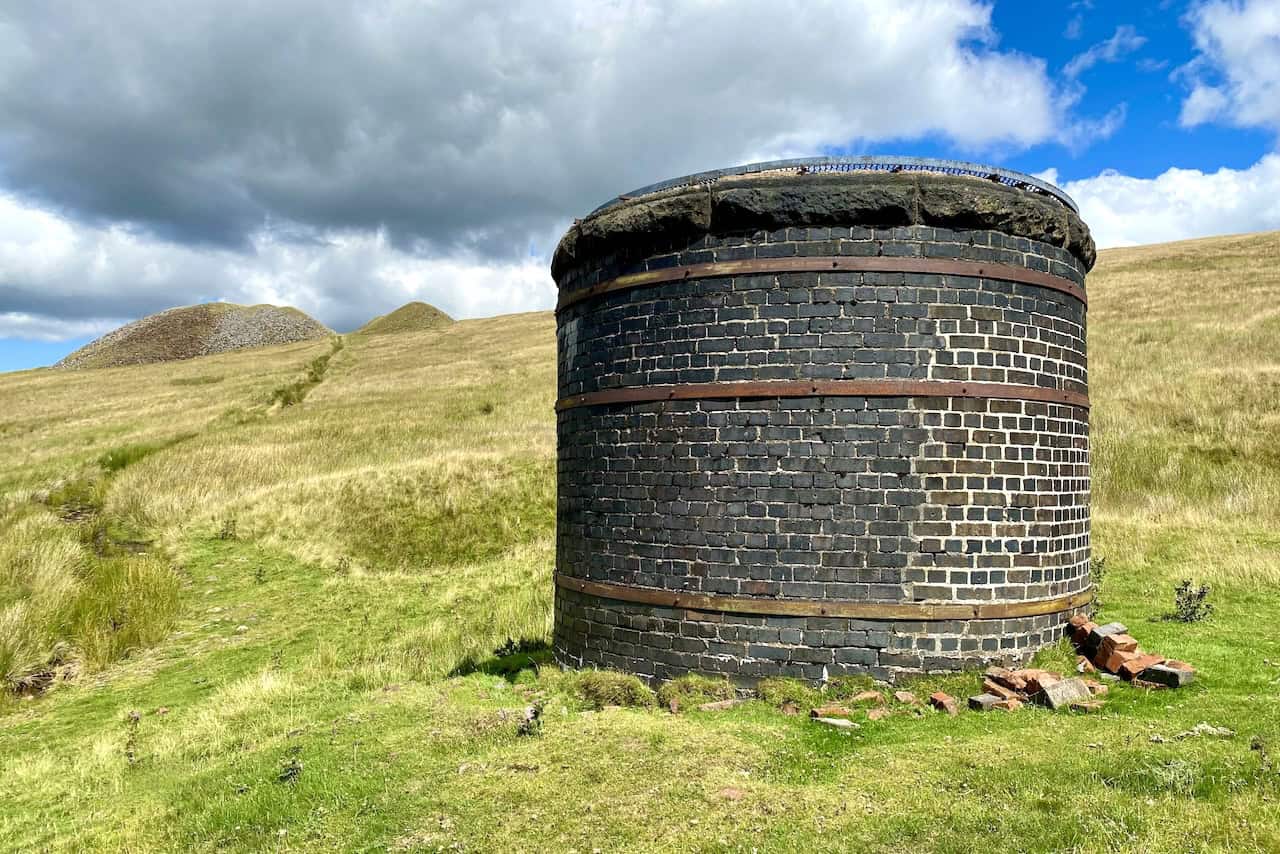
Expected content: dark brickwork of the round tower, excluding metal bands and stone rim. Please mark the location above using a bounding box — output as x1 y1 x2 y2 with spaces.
556 170 1092 681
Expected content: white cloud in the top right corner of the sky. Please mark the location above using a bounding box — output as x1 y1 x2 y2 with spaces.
1179 0 1280 131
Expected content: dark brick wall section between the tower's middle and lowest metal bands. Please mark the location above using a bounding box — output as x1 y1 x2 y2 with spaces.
557 397 1089 602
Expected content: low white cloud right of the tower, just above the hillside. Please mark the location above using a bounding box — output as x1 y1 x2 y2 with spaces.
1041 154 1280 248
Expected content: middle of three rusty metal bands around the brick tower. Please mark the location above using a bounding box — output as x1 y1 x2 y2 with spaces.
556 379 1089 412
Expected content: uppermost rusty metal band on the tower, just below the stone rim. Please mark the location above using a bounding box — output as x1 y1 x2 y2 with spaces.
556 261 1088 317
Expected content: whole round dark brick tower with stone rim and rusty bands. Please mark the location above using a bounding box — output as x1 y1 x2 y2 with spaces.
552 157 1094 684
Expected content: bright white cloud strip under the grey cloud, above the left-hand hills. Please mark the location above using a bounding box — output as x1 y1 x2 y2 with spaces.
0 195 554 341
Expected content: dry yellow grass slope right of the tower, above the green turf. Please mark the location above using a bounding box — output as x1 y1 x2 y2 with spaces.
1089 226 1280 585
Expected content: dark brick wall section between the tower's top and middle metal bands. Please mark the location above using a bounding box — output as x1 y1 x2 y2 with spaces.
558 228 1088 397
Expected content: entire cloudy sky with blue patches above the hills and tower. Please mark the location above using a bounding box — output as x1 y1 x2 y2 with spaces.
0 0 1280 370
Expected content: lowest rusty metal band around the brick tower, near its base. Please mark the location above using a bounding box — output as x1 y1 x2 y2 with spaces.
556 572 1093 621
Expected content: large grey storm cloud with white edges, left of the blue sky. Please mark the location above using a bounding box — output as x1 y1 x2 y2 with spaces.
0 0 1131 334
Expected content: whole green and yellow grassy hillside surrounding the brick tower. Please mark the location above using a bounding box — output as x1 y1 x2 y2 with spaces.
0 234 1280 851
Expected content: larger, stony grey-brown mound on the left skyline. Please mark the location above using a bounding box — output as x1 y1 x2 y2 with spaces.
55 302 333 367
